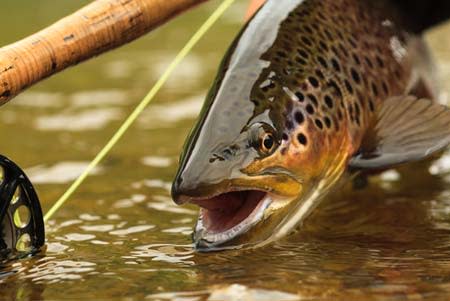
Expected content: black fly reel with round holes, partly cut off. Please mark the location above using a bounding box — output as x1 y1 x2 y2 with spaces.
0 155 45 260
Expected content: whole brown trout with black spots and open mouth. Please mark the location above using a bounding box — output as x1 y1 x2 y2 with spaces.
172 0 450 250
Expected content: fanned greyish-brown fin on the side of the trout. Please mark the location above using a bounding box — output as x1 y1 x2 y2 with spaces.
349 95 450 169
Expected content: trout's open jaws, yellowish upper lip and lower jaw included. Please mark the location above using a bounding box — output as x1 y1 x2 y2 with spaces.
174 174 302 251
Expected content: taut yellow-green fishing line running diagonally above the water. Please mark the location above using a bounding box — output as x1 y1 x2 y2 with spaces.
44 0 235 222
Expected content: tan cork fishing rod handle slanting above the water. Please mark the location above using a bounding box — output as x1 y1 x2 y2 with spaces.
0 0 206 105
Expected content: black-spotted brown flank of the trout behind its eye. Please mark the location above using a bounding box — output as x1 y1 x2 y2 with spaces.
244 0 420 174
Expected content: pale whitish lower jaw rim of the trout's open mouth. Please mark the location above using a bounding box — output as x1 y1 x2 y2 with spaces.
193 193 274 251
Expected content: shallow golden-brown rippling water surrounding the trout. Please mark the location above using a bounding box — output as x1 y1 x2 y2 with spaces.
0 0 450 300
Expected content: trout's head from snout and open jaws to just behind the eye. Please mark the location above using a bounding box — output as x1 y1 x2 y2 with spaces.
172 62 342 250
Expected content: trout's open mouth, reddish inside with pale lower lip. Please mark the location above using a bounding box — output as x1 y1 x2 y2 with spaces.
191 190 271 248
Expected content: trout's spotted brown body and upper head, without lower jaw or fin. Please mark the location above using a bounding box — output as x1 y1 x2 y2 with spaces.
172 0 448 248
